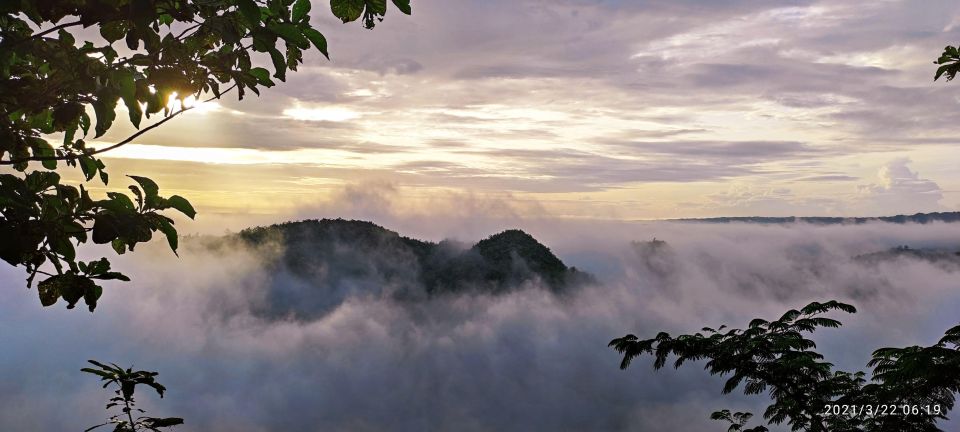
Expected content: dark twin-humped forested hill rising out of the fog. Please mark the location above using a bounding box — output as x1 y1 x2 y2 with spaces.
225 219 592 313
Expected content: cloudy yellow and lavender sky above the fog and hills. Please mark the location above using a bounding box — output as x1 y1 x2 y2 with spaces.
62 0 960 230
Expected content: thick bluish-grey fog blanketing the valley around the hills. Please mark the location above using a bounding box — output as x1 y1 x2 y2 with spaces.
0 218 960 432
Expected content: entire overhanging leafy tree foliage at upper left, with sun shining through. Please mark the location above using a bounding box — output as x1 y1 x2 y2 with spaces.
0 0 410 311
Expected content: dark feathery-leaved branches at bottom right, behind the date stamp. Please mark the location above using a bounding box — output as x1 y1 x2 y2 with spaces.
610 301 960 432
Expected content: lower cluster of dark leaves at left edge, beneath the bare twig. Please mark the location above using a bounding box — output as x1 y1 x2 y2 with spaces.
0 171 196 312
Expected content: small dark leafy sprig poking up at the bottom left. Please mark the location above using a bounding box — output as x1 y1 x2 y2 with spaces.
81 360 183 432
